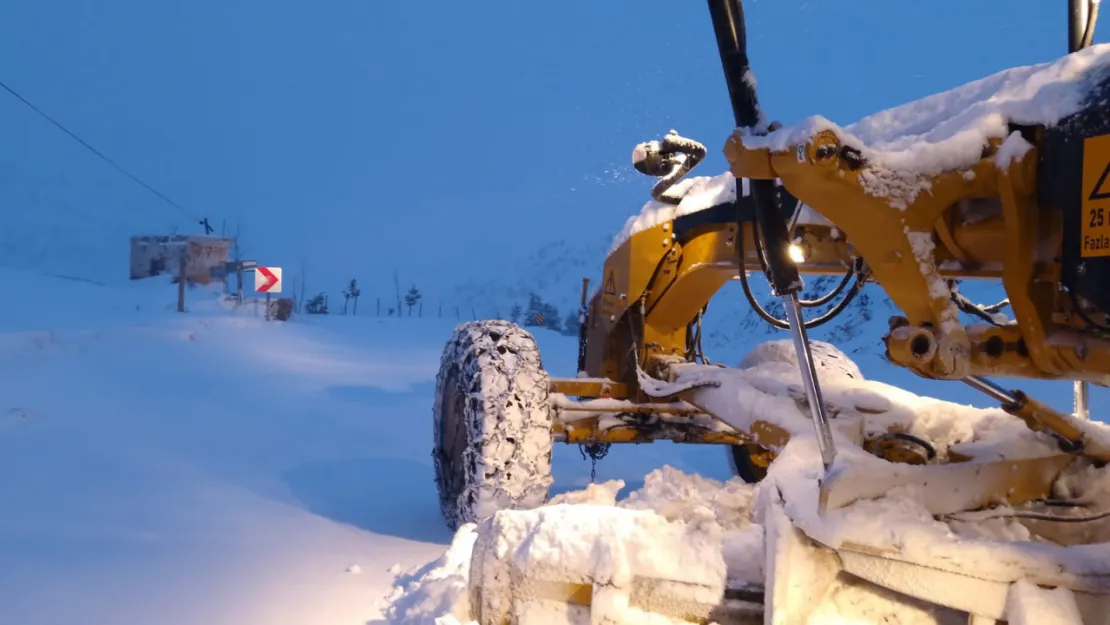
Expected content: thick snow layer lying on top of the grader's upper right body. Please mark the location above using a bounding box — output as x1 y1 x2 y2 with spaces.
743 43 1110 208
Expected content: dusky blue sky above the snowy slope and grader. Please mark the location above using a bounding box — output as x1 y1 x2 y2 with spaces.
0 0 1092 292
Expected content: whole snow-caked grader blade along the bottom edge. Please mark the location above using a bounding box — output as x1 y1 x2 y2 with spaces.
468 486 1110 625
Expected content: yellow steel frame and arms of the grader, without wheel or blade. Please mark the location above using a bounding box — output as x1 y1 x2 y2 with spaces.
539 0 1110 488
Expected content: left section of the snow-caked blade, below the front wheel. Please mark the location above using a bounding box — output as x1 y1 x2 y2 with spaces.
470 506 764 625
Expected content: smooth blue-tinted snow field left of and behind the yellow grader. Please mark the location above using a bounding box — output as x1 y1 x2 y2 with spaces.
0 265 1104 625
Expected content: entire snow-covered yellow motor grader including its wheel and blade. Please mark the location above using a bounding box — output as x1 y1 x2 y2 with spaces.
434 0 1110 624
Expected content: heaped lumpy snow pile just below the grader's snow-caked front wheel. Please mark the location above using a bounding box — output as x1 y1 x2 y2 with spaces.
386 466 763 625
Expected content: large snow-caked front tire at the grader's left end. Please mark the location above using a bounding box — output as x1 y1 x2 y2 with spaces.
433 321 554 531
